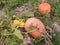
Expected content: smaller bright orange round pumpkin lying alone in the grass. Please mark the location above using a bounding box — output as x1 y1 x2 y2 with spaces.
38 2 51 14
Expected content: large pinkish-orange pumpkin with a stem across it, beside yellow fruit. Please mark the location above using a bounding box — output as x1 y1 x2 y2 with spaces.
25 17 45 38
